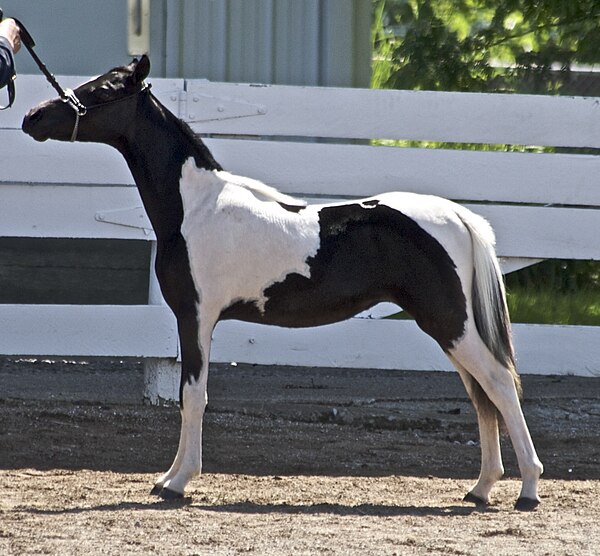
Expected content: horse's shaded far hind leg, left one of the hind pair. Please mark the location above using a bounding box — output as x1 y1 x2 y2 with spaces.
450 357 504 506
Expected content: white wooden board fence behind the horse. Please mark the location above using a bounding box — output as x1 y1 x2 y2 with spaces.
0 76 600 397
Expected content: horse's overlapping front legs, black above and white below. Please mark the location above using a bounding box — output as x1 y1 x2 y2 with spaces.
152 316 213 499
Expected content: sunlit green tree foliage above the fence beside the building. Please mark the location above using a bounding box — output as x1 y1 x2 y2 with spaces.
373 0 600 93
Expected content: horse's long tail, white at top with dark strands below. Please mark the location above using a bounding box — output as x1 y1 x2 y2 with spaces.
457 206 521 396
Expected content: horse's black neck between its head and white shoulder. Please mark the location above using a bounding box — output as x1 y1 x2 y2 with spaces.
118 97 220 238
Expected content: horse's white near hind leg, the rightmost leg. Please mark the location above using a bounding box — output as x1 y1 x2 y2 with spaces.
450 325 543 510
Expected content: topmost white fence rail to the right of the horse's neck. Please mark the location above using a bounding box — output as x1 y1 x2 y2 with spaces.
188 81 600 148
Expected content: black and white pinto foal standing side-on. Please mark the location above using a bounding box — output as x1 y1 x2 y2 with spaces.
22 55 543 510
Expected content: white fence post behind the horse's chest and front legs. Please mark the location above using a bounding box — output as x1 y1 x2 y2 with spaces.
144 241 181 405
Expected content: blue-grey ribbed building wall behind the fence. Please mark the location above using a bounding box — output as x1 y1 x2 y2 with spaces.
2 0 371 87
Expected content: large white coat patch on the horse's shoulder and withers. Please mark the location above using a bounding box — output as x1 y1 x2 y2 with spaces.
179 159 319 319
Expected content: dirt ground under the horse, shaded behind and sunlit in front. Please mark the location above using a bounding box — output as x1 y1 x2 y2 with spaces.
0 359 600 556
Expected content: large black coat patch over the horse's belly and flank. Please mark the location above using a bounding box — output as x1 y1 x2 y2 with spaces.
221 200 467 350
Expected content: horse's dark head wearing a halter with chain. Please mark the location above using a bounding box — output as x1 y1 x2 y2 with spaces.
22 55 150 144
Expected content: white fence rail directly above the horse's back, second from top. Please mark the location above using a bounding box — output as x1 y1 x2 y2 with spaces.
206 140 600 206
